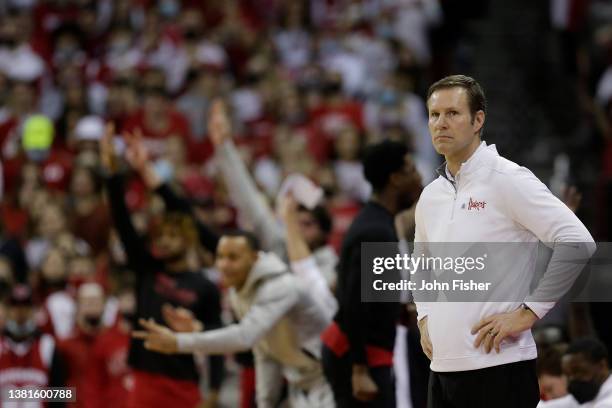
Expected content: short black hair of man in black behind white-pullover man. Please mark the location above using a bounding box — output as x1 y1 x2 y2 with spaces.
362 140 408 192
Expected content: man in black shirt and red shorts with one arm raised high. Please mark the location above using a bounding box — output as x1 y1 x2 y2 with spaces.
100 126 223 407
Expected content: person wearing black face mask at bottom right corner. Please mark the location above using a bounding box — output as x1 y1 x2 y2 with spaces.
537 338 612 408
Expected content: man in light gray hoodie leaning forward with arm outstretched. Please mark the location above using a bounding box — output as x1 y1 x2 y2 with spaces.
134 232 334 408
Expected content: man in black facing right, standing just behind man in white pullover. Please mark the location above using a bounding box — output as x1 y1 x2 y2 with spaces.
323 141 421 408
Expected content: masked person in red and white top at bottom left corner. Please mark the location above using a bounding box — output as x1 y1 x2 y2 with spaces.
0 284 65 407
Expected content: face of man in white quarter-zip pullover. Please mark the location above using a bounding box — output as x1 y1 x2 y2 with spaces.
427 87 484 158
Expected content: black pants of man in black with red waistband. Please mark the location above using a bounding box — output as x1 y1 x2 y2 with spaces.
323 346 395 408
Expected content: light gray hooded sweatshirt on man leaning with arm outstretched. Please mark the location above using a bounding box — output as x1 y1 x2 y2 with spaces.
178 252 330 407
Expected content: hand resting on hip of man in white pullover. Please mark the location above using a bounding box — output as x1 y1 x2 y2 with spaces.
470 308 538 353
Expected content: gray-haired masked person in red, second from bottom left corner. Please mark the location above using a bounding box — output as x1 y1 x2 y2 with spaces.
58 282 106 407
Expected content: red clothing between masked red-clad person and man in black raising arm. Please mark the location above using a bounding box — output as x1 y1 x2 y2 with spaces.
85 325 134 408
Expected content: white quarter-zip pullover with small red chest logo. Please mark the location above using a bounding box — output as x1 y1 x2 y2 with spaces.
415 142 595 372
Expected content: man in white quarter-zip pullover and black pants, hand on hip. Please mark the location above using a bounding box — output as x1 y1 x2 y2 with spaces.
415 75 595 408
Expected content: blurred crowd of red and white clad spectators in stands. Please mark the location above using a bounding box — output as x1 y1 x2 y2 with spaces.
0 0 612 406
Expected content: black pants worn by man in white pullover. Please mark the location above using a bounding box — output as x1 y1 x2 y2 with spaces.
428 360 540 408
